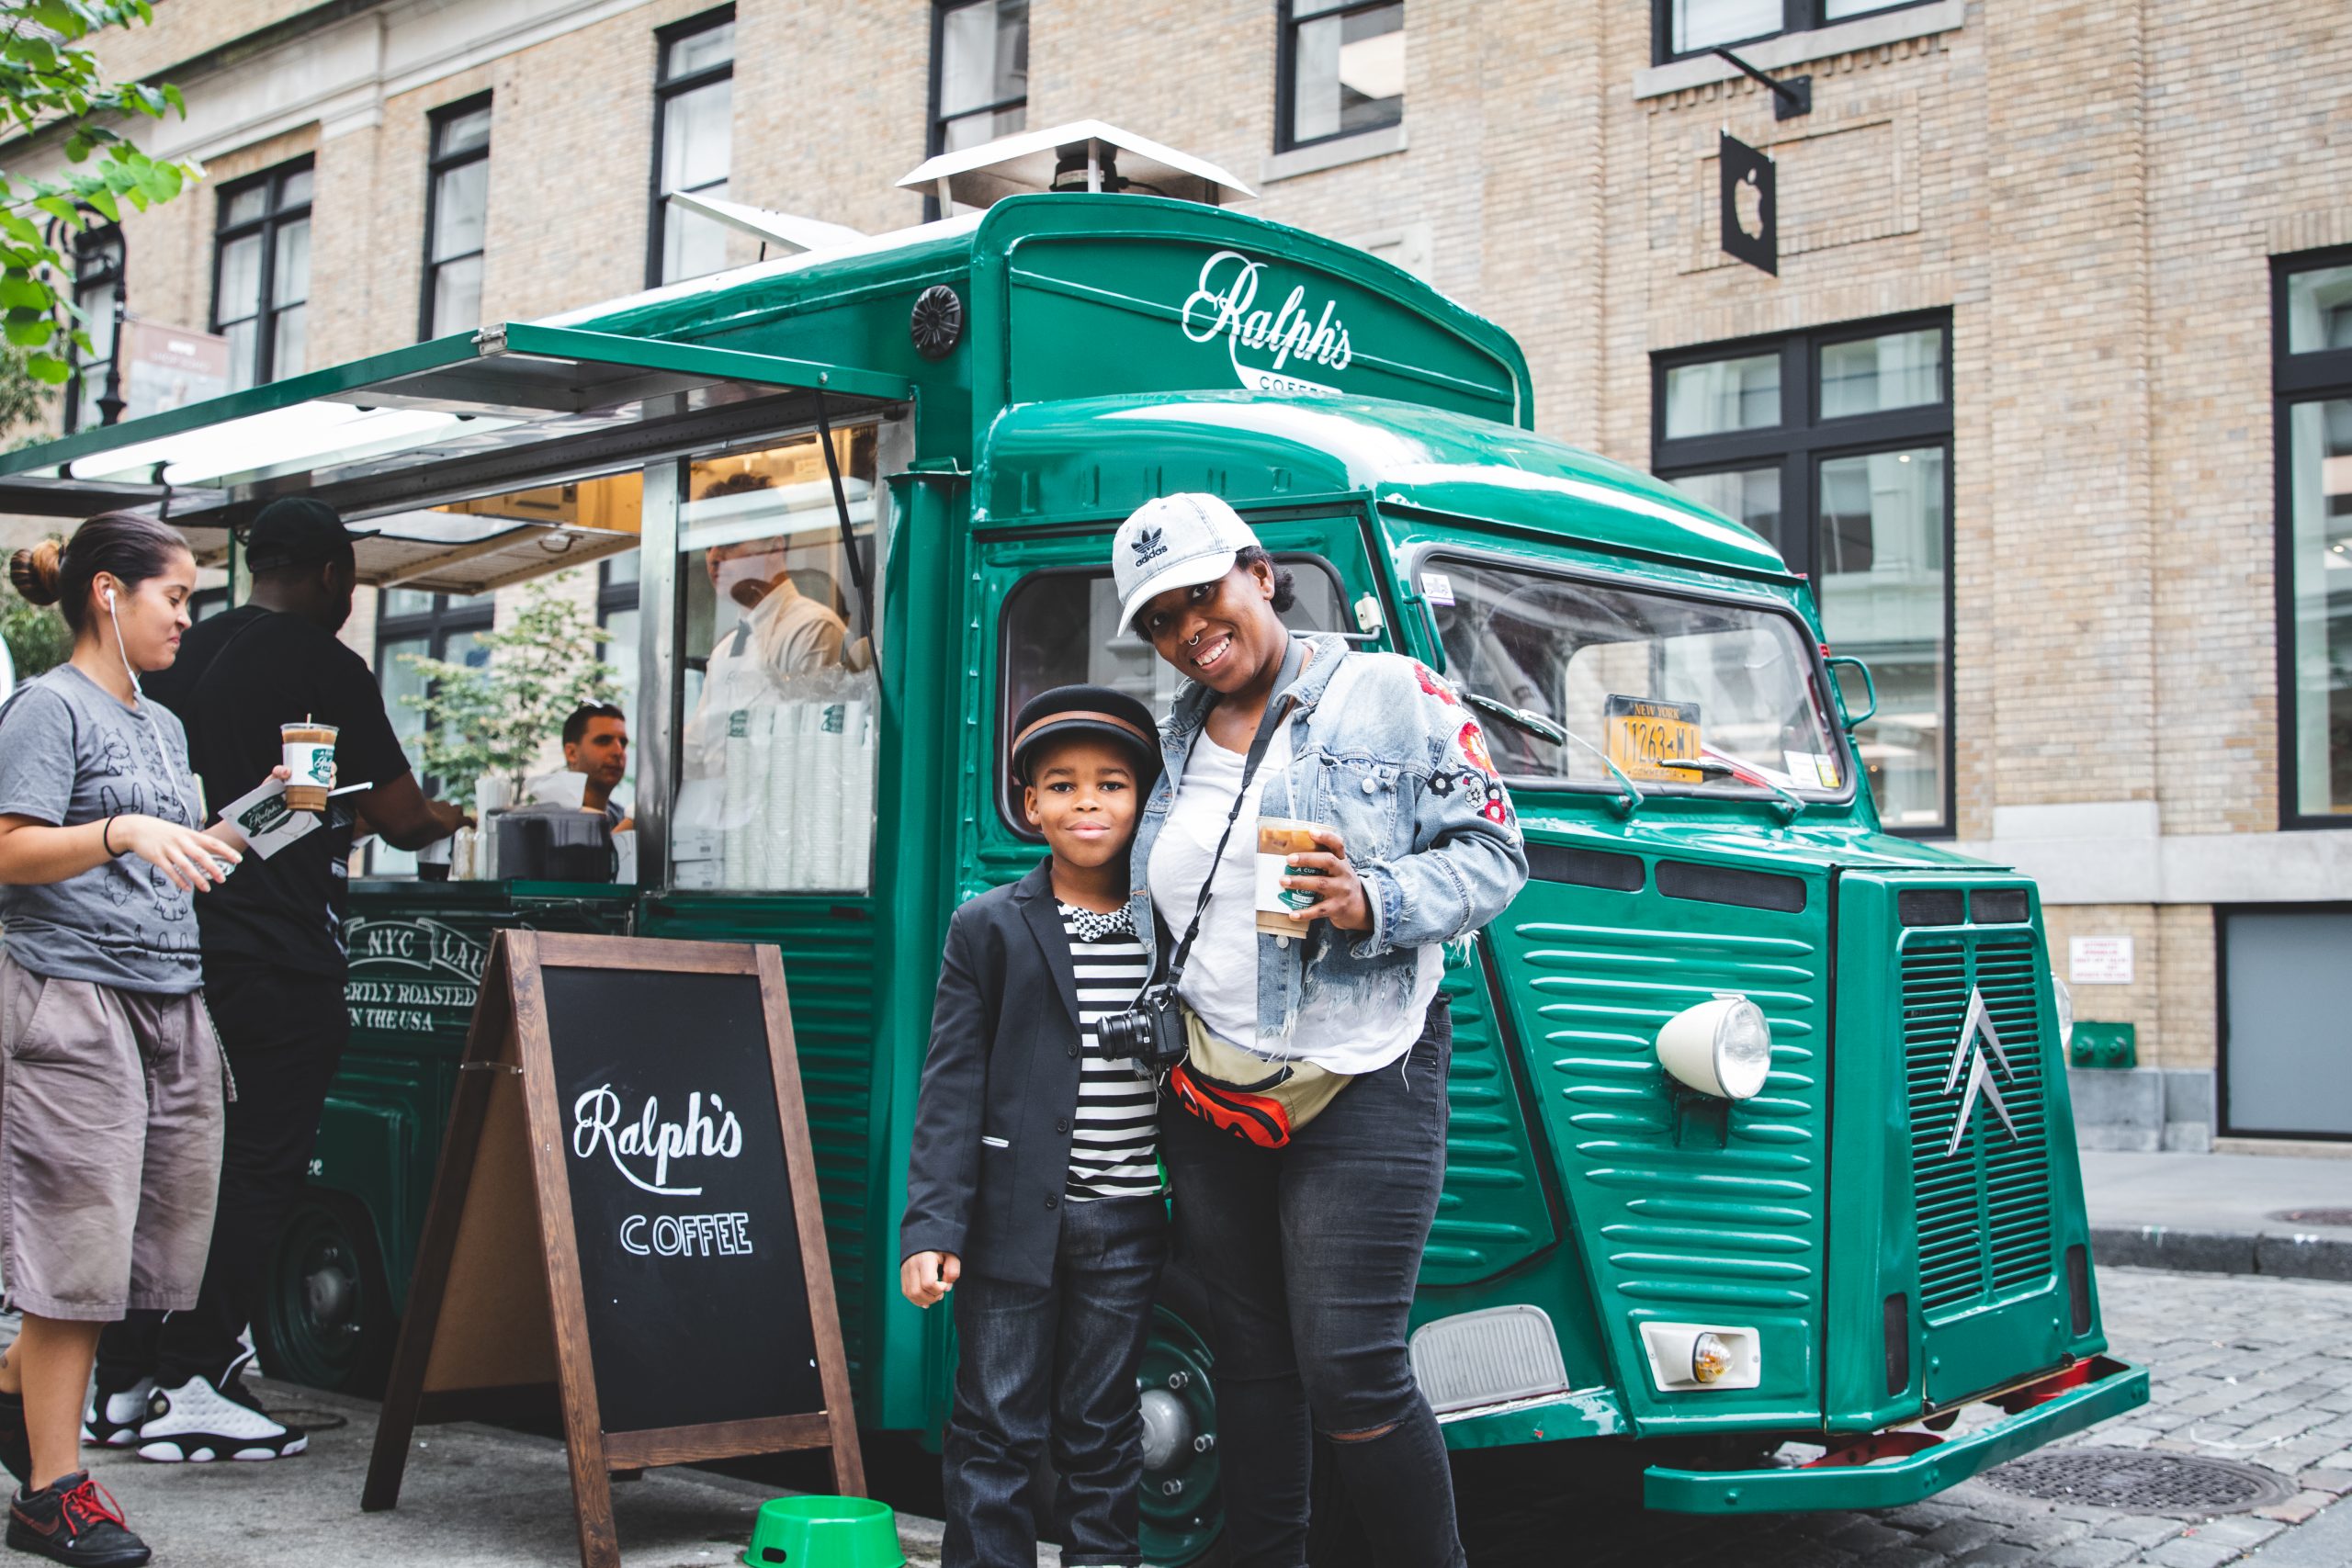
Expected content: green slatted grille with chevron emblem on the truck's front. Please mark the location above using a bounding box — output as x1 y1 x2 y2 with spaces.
1903 938 2051 1316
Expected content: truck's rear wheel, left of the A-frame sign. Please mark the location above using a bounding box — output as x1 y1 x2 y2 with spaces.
254 1190 395 1396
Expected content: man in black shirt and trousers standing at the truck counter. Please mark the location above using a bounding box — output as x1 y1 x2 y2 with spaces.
85 496 466 1460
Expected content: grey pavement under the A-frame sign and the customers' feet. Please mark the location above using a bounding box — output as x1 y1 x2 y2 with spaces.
78 1378 1001 1568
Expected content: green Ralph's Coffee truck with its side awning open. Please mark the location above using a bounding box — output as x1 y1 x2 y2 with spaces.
0 125 2147 1563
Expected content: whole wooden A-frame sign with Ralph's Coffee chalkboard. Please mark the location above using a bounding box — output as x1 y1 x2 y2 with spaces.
360 931 865 1568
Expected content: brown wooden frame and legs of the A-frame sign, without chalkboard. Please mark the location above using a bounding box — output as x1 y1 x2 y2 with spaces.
360 931 865 1568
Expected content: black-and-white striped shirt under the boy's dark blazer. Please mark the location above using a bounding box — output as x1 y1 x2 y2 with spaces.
1058 903 1162 1201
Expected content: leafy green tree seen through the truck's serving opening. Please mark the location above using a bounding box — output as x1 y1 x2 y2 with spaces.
400 571 621 799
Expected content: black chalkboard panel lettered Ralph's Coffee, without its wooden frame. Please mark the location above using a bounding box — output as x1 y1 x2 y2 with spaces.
546 968 826 1432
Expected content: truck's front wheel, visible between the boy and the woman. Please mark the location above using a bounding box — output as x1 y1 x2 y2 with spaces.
1136 1265 1226 1568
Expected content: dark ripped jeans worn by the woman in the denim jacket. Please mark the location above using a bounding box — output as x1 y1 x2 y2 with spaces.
1159 995 1463 1568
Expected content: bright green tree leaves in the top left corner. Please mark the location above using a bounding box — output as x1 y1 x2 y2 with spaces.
0 0 198 386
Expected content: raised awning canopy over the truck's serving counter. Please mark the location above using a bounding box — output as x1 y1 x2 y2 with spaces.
0 322 912 592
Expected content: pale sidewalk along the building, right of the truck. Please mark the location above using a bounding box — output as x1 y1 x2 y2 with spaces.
2082 1149 2352 1281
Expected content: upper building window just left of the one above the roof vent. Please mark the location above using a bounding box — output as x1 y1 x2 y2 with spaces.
644 5 734 285
